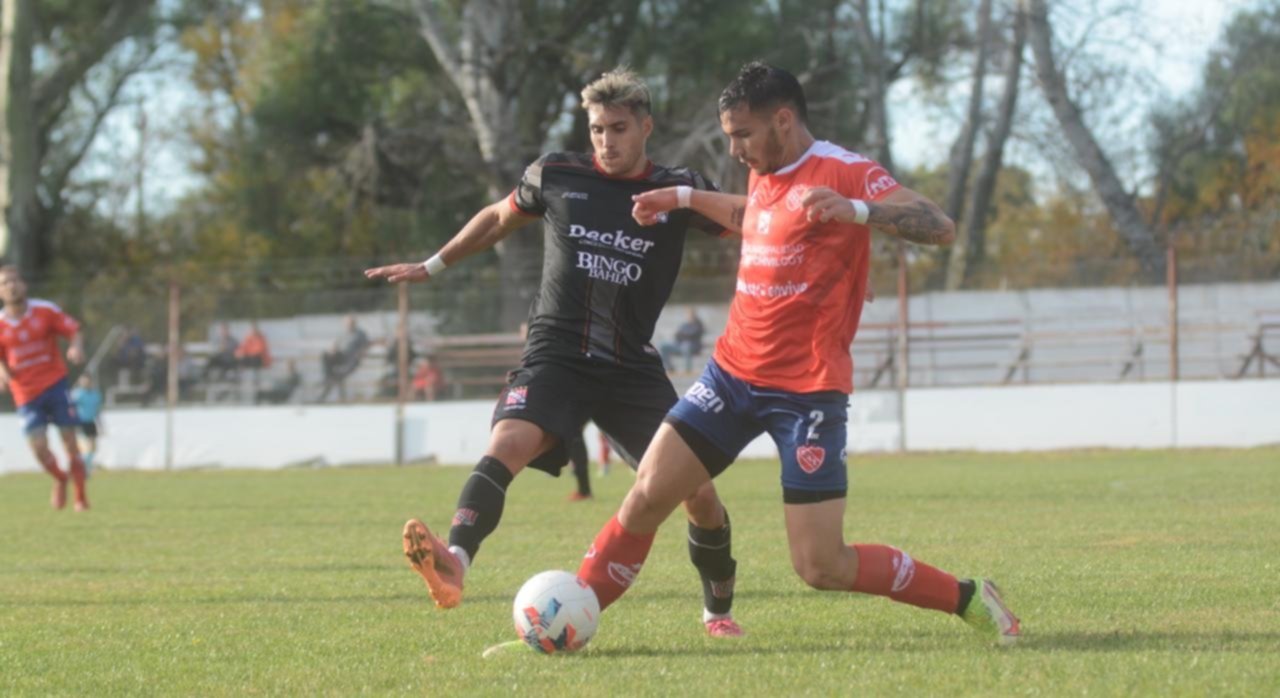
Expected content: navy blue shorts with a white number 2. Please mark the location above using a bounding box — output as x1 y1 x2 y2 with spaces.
666 361 849 503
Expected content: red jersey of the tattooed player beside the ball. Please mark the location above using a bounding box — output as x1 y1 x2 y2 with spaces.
716 141 900 393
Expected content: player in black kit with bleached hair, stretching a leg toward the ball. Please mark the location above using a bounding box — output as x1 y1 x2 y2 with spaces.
365 69 742 637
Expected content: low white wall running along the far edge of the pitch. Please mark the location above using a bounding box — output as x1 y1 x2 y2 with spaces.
0 380 1280 473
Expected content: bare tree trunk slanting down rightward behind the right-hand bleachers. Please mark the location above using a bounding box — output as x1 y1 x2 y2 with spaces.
1019 0 1165 280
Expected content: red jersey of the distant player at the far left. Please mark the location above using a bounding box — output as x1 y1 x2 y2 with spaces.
0 298 79 406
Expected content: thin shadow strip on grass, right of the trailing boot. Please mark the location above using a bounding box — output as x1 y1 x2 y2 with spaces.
1018 630 1280 653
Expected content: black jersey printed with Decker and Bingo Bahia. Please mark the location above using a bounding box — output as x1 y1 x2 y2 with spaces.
509 152 723 368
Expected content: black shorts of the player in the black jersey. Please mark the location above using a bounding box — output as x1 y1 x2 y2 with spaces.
493 361 676 475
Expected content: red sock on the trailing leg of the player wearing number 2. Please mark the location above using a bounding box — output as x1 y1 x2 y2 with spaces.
851 544 960 613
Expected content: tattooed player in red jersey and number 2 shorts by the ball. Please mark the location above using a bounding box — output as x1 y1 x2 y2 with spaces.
579 63 1020 643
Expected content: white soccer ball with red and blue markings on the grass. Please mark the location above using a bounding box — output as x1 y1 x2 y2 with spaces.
511 570 600 654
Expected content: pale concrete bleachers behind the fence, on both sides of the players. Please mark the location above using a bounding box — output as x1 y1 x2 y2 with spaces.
106 282 1280 403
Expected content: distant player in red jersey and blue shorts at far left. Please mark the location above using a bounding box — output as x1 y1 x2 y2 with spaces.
0 266 88 511
